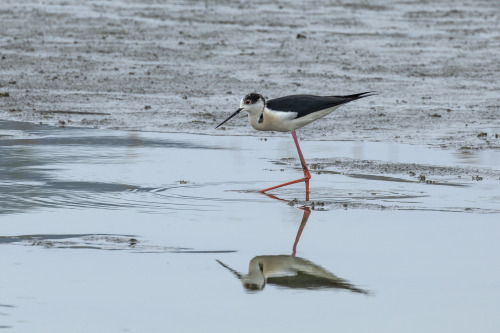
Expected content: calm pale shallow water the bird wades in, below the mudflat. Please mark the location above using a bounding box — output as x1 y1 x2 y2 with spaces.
0 121 500 332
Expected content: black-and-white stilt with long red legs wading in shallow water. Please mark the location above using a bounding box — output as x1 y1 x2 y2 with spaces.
215 92 374 201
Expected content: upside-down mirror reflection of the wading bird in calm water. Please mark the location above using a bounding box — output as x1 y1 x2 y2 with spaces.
217 198 368 294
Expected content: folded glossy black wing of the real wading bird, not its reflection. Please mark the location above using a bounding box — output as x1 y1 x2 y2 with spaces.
266 91 374 118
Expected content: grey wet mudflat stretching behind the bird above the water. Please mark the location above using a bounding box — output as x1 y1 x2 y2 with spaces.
0 0 500 149
